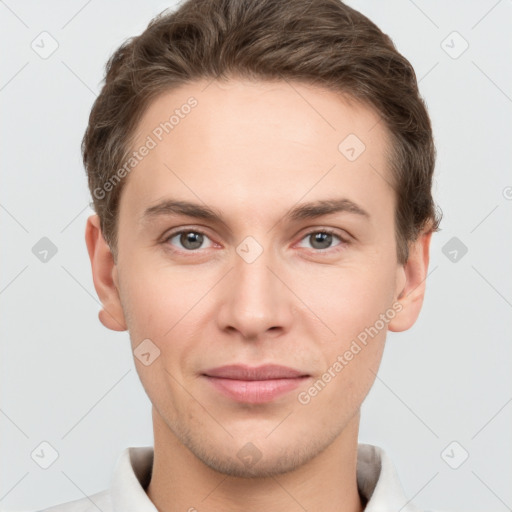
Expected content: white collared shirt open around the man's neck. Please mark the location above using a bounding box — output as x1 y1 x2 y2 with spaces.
40 443 428 512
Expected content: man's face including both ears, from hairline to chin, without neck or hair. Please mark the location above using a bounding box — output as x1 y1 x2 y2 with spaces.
88 80 428 476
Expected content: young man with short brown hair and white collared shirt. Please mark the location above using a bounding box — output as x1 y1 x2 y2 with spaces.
42 0 440 512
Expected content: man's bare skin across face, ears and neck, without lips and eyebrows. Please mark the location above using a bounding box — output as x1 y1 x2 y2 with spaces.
86 79 431 512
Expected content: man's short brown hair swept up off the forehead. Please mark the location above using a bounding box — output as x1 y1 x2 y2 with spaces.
82 0 441 264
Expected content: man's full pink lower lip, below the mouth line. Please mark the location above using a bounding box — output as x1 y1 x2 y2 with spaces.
205 375 308 404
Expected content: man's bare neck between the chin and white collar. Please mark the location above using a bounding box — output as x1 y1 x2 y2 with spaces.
146 408 364 512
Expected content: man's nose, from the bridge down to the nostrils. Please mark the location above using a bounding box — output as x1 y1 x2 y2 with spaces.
217 242 294 341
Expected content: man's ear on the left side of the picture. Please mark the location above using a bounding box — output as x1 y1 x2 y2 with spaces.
85 215 127 331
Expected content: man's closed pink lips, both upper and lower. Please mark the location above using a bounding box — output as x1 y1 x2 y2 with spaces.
202 364 310 404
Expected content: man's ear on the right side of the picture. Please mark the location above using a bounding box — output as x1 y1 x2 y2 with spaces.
388 231 432 332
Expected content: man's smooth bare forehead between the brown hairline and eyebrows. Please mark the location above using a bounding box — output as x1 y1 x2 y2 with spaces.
121 80 393 230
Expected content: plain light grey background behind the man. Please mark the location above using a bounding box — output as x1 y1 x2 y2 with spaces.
0 0 512 512
